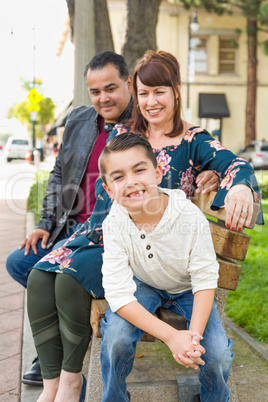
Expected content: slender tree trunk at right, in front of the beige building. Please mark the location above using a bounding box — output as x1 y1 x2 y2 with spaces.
245 19 257 145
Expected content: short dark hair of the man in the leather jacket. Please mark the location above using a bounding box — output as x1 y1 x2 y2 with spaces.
84 50 129 81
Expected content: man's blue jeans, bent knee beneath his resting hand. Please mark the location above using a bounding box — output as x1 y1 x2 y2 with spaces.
6 222 82 288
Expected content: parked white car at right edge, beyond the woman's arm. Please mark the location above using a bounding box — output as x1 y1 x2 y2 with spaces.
238 141 268 170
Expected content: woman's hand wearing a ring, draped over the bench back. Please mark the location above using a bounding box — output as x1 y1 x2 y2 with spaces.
224 184 253 232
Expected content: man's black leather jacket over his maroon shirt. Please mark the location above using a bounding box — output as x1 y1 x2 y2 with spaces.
38 101 132 247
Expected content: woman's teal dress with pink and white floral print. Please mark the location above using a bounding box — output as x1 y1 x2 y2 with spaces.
34 125 263 298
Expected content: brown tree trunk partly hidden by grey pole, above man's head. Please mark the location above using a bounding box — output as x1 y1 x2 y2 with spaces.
66 0 114 53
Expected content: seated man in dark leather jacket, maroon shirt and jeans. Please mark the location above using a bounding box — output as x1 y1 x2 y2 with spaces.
6 51 132 385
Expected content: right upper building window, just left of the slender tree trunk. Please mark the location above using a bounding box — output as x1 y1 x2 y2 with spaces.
219 38 238 74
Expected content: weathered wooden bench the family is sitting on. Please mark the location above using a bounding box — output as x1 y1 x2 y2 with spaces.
86 192 259 402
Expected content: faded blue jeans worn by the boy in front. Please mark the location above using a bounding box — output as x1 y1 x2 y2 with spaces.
101 278 234 402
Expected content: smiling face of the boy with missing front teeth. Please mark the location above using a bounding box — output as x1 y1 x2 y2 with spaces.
103 146 162 213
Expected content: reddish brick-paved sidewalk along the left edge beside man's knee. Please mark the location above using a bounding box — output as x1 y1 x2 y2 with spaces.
0 199 26 402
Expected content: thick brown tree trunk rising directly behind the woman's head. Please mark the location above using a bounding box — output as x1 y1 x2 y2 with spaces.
123 0 162 74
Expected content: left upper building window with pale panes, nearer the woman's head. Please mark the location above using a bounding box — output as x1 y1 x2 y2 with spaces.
190 36 208 74
